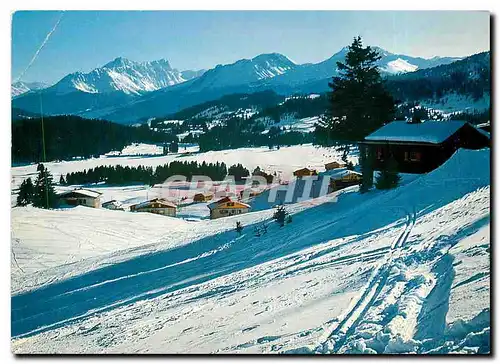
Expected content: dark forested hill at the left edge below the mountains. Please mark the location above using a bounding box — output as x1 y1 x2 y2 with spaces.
12 115 177 163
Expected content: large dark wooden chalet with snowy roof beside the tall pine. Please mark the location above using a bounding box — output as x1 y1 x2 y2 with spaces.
360 120 491 173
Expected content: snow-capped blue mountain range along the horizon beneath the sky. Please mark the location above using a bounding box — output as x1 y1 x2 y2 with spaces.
12 47 470 123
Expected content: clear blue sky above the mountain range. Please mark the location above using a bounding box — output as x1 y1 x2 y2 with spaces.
12 11 490 83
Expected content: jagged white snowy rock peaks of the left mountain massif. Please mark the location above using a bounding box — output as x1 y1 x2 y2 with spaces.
51 57 196 95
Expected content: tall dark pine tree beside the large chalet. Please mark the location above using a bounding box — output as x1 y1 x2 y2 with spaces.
315 37 395 145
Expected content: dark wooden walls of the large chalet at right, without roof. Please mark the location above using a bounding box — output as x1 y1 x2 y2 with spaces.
362 124 491 173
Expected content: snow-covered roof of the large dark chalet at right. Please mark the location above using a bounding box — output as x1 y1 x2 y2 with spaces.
365 120 467 144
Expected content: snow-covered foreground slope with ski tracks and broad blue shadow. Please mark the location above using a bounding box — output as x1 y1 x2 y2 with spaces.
12 150 490 353
